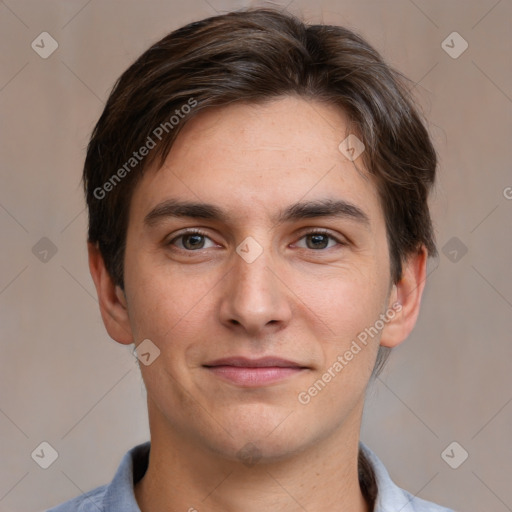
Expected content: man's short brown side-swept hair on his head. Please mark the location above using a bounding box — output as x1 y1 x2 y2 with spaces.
83 9 437 372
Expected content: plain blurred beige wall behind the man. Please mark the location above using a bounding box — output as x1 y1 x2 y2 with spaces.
0 0 512 512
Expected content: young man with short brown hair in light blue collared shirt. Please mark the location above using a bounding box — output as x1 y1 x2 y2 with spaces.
48 10 454 512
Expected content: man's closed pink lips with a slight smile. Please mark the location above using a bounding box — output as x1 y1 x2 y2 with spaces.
203 357 309 387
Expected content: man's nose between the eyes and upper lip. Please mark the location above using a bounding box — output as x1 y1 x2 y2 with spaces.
220 243 292 337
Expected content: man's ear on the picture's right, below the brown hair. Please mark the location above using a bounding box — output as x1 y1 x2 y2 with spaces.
380 246 427 348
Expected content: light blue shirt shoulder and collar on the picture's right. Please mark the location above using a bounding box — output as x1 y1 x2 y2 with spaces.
360 443 454 512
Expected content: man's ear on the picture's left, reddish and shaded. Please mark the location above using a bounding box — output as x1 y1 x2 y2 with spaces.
87 242 133 345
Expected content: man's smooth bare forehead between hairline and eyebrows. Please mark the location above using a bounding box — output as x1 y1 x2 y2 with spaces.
130 97 381 229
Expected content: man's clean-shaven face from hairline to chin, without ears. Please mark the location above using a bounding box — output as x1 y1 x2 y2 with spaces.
124 97 393 459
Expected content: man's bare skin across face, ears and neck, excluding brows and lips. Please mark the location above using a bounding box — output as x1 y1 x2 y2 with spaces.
89 97 426 512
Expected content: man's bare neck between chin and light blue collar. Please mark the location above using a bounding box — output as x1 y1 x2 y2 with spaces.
135 400 370 512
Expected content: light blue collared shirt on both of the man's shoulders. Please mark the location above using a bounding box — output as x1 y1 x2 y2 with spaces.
46 442 454 512
